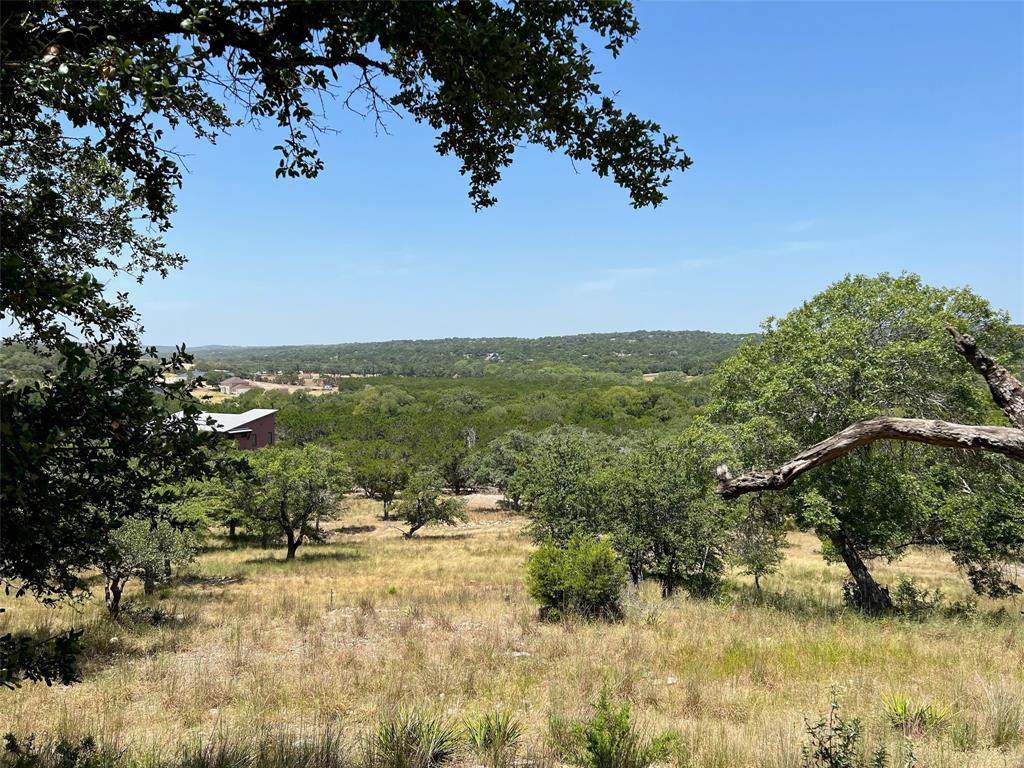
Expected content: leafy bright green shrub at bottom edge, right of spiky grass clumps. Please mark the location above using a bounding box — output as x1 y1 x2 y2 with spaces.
552 686 675 768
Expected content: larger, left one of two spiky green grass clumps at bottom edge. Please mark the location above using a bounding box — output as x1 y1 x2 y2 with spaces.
367 711 459 768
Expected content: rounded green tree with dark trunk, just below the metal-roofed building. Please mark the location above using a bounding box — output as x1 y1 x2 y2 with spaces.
237 444 352 560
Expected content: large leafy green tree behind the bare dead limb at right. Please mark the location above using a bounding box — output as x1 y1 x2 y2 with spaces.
714 274 1024 610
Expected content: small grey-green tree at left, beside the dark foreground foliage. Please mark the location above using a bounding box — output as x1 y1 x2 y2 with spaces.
100 517 196 618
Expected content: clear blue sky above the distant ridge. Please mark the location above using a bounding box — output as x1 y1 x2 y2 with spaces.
132 2 1024 346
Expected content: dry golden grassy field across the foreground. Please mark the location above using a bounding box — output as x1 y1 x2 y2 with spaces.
0 500 1024 768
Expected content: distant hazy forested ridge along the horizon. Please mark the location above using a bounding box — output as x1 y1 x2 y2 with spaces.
178 331 753 376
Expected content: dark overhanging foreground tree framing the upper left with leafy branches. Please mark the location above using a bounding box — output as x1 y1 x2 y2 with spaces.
0 0 690 684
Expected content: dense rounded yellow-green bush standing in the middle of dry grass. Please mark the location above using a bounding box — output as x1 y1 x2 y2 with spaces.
526 536 626 620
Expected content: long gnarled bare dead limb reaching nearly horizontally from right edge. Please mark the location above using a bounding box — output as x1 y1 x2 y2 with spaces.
717 416 1024 499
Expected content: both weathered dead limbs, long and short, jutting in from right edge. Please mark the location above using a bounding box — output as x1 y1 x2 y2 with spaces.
717 328 1024 499
